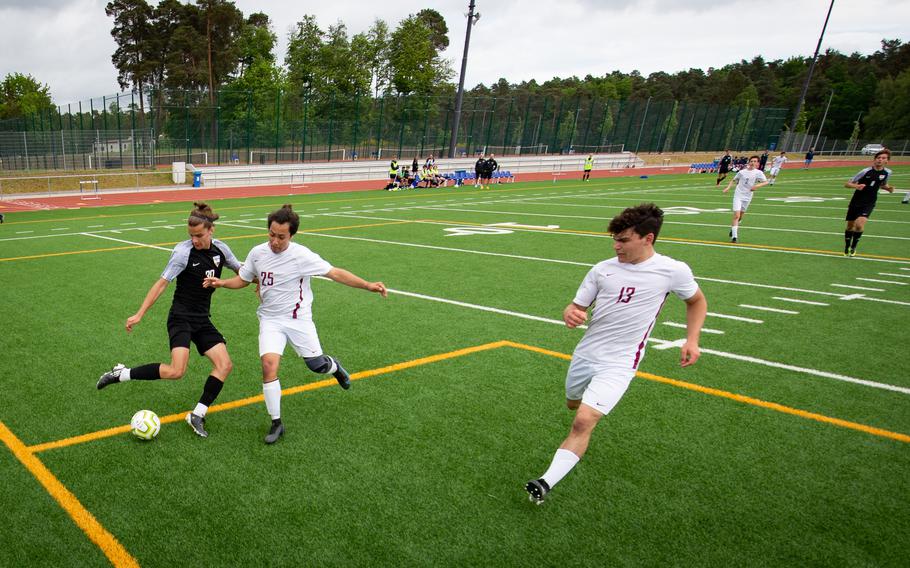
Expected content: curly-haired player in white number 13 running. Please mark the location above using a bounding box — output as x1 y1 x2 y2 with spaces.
525 203 708 504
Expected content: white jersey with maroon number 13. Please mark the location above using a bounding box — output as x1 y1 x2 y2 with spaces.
572 253 698 369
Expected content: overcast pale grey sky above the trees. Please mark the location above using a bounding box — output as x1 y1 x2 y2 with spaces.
0 0 910 105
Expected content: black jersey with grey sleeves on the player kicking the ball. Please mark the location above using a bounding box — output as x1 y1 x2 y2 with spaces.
161 239 240 317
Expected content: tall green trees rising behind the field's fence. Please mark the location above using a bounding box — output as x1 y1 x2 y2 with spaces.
0 0 910 139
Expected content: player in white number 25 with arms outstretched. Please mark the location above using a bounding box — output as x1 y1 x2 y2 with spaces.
204 204 388 444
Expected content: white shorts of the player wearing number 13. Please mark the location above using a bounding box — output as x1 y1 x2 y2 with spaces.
566 357 635 414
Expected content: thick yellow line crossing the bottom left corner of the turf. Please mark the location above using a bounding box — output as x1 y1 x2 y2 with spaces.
0 421 139 568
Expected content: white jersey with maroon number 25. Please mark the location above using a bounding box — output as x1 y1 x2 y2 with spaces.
239 242 332 320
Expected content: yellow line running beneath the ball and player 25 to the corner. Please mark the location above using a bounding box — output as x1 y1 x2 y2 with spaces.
27 341 509 453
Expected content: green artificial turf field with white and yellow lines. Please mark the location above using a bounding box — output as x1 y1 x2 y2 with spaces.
0 168 910 566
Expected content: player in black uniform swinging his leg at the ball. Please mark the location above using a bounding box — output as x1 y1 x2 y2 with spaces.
96 203 240 438
